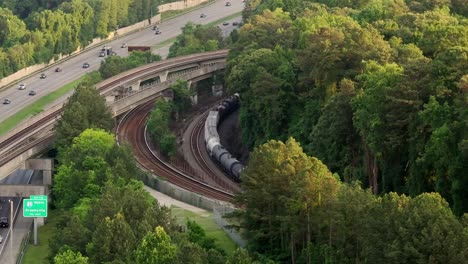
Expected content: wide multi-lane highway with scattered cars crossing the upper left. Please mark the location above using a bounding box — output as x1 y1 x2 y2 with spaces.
0 0 244 122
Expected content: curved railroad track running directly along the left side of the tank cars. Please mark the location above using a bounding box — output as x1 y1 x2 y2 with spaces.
190 108 240 193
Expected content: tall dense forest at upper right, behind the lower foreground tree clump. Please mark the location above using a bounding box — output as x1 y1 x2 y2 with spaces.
226 0 468 215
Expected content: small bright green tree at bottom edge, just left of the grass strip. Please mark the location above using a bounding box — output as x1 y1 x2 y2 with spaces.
135 226 177 264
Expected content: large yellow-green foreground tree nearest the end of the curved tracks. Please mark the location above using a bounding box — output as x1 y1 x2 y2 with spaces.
235 139 338 262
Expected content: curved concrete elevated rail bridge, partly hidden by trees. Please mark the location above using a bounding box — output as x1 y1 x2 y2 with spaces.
0 50 228 182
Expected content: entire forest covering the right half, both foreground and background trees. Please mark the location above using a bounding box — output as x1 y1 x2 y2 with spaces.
219 0 468 263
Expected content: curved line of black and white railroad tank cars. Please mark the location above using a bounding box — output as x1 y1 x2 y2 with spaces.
205 93 244 181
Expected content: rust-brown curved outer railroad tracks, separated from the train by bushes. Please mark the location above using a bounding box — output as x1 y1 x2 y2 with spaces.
117 101 233 202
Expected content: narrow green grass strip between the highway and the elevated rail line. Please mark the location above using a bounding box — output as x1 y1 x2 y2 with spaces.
0 77 84 136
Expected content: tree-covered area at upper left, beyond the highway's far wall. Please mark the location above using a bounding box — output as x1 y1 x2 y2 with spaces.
0 0 166 78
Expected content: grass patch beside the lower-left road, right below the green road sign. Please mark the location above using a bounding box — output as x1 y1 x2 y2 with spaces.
23 210 60 264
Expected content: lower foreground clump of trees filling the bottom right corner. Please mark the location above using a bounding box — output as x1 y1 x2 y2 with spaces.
232 139 468 263
